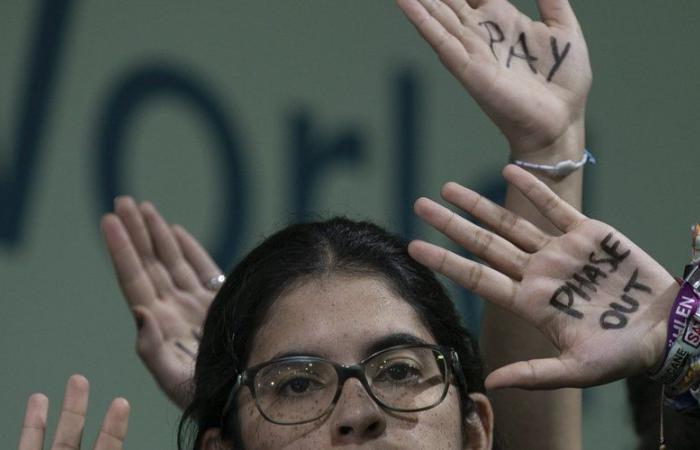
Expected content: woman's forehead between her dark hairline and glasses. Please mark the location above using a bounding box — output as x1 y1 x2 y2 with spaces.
248 274 435 366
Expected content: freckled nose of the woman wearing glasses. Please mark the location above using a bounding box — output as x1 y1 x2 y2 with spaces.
331 378 386 444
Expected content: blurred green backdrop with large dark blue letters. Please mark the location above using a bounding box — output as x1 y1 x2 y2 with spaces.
0 0 700 449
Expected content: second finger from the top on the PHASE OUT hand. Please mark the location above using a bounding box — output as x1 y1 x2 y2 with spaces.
441 182 551 253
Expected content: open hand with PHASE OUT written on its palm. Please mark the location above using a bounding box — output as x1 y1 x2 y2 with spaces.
409 165 678 389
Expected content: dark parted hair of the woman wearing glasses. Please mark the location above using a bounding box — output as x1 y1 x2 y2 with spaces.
178 218 484 449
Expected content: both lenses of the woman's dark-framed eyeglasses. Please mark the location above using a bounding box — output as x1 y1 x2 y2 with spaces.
254 347 447 424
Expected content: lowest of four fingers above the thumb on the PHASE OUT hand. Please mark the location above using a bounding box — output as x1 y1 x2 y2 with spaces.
408 241 521 314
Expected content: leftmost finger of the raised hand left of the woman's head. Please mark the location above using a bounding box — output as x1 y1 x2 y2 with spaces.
101 214 157 307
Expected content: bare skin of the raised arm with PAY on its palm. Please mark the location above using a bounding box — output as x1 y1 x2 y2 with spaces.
397 0 592 450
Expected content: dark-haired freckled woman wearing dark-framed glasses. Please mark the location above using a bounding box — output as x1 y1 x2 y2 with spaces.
181 218 492 448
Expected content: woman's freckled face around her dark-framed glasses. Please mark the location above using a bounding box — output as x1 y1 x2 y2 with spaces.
208 275 492 450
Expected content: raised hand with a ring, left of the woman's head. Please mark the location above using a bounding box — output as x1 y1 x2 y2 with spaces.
102 197 221 408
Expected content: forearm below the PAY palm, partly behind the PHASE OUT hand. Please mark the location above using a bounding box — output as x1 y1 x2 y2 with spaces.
481 121 584 450
